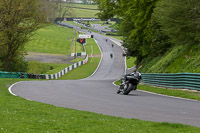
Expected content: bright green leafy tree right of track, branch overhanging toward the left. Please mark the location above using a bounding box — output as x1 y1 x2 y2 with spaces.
97 0 170 64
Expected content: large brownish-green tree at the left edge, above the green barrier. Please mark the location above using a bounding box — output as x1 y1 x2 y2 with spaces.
0 0 45 71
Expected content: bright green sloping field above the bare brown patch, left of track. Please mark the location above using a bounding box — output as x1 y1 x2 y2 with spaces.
26 25 74 55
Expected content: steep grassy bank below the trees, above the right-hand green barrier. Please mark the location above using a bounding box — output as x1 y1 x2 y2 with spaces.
140 45 200 73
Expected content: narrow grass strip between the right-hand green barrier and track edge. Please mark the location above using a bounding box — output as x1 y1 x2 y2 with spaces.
115 80 200 100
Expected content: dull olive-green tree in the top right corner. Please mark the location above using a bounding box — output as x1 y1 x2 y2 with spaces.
154 0 200 45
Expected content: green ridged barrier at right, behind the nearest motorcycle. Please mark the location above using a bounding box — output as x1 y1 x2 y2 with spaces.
142 73 200 90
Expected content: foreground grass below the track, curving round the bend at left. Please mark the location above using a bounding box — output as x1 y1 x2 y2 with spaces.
0 79 200 133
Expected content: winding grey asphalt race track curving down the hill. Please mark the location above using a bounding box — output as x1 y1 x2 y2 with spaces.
12 23 200 127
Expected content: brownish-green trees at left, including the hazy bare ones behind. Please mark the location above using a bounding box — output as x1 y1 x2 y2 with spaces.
0 0 72 72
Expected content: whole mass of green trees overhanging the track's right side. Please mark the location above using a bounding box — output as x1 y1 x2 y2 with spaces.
96 0 200 65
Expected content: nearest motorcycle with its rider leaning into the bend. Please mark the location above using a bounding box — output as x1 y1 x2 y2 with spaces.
117 72 141 95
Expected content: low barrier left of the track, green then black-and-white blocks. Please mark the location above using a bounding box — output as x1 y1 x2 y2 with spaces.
0 55 88 79
